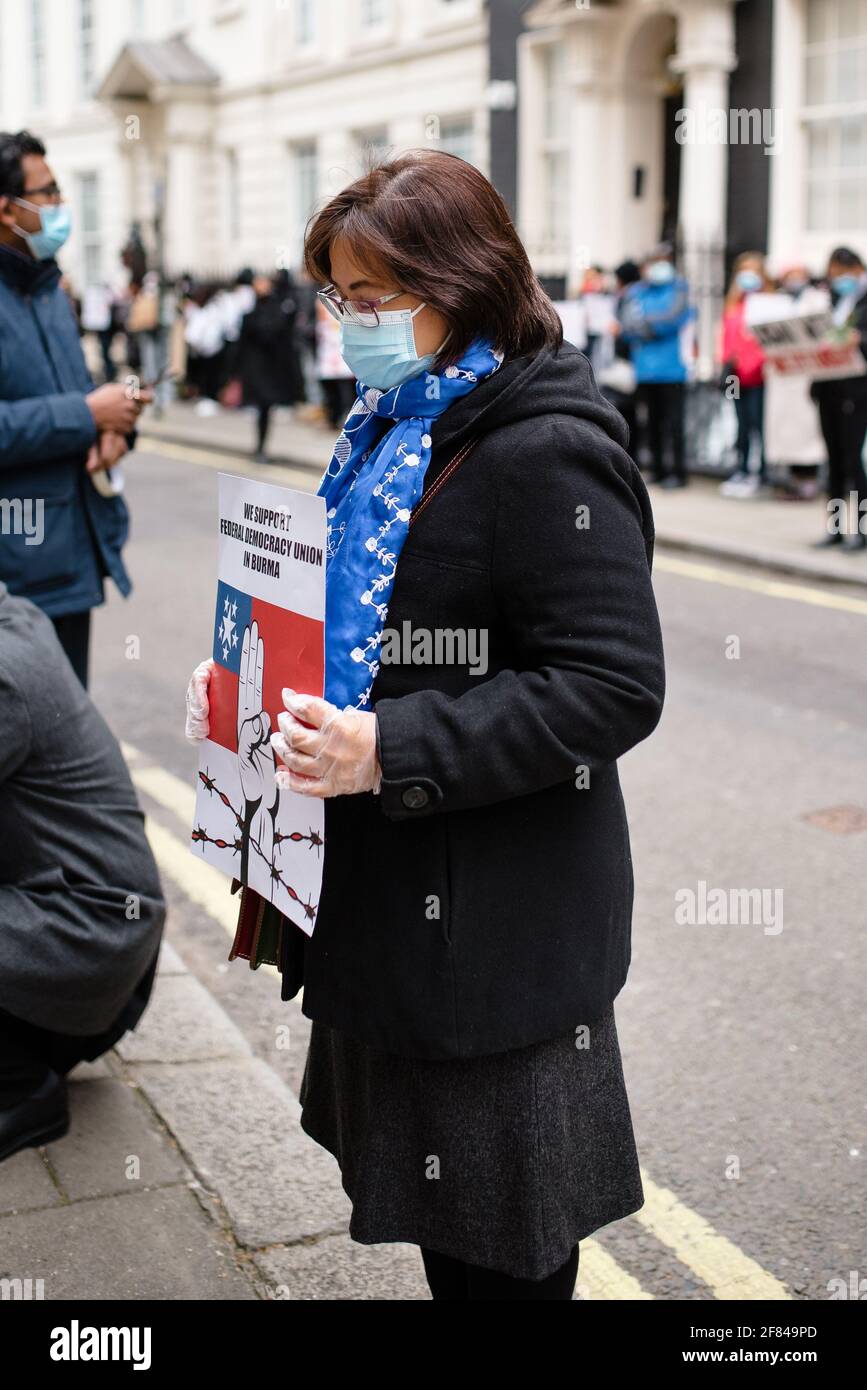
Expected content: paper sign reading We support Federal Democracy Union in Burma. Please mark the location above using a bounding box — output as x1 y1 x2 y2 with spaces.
192 475 324 933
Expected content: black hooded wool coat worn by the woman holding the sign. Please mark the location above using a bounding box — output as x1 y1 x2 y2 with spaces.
281 343 664 1058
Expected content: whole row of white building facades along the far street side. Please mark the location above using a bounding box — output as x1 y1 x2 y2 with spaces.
0 0 867 349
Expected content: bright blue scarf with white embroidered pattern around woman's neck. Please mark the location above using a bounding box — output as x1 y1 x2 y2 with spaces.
318 339 503 709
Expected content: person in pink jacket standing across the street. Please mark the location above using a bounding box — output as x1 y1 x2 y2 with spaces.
720 252 771 496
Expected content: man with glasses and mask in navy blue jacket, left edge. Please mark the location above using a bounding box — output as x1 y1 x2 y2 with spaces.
0 131 151 687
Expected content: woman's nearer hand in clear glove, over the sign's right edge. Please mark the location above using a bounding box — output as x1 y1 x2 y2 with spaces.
271 689 382 796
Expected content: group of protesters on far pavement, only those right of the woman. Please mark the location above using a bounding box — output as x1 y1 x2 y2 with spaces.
560 243 867 550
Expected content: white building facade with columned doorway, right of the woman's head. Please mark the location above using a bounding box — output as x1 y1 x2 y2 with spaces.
517 0 867 375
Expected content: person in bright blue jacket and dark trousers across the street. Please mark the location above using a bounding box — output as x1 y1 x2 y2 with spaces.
618 242 695 488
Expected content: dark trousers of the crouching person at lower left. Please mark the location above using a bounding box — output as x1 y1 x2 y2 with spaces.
0 952 158 1109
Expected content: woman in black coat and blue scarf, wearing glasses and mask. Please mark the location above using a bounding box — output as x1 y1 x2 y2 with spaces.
188 152 664 1301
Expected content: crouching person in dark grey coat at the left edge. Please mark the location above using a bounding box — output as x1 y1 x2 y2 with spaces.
0 582 165 1161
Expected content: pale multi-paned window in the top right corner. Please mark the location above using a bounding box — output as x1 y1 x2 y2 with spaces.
803 0 867 232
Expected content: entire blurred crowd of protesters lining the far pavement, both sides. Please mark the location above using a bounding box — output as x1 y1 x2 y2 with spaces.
64 227 867 549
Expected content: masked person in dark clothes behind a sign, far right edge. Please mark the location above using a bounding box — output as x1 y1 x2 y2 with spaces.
810 246 867 553
